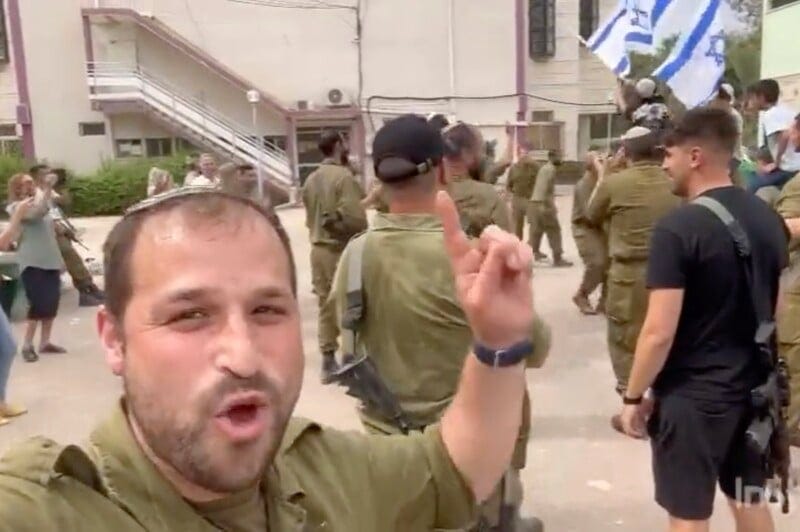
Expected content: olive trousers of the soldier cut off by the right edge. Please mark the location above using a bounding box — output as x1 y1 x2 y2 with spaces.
778 286 800 431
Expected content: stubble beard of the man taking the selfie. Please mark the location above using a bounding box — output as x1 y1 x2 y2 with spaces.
124 368 294 493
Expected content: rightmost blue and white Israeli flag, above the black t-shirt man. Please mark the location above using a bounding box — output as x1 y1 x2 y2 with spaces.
654 0 725 109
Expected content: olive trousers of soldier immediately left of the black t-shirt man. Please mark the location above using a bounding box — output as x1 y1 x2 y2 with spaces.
606 259 647 393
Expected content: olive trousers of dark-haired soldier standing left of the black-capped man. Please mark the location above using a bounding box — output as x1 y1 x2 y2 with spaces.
311 244 344 353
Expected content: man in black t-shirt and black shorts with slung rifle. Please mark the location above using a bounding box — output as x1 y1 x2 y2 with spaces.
622 109 788 532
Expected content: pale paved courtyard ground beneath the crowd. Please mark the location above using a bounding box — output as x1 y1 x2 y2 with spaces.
0 192 800 532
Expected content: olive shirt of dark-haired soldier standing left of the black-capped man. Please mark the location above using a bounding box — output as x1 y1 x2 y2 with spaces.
302 159 367 246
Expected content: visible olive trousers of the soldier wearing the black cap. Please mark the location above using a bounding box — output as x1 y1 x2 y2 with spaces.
360 390 531 532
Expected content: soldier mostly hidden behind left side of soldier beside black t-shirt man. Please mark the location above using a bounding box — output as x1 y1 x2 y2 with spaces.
572 158 608 315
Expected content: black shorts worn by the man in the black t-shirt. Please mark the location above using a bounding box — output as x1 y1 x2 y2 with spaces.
647 395 767 521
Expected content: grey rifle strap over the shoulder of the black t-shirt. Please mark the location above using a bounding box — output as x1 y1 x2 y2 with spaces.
692 196 775 365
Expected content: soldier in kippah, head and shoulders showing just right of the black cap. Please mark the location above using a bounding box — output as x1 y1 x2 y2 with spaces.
442 122 511 238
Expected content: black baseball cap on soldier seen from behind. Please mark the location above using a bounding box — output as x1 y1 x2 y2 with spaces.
372 115 444 183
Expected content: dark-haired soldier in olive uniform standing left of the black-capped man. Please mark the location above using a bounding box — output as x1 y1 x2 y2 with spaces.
302 131 367 384
